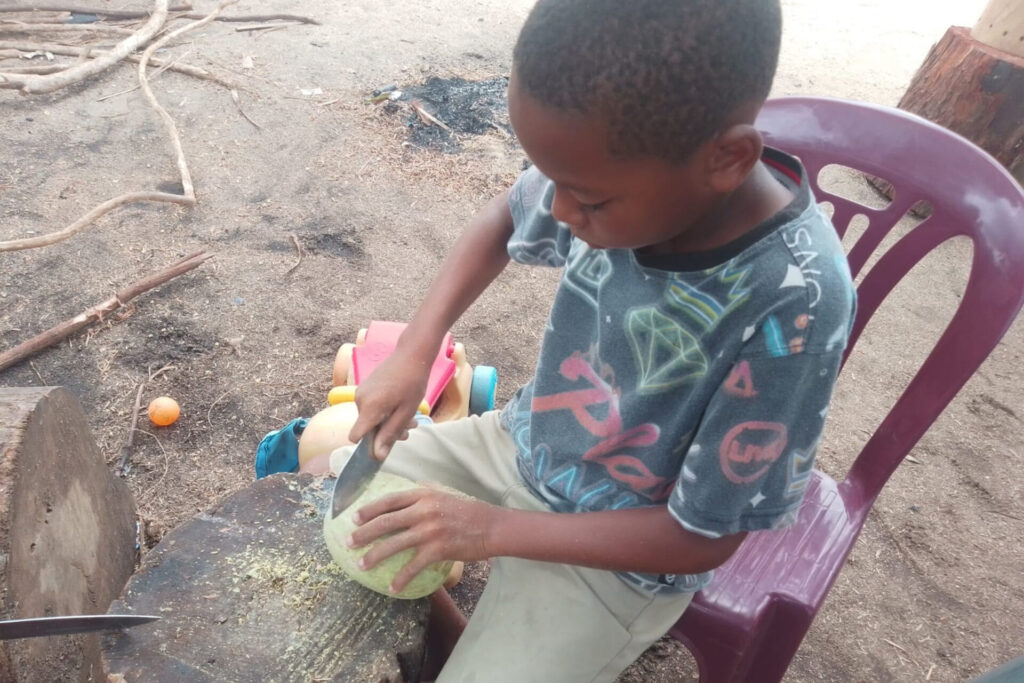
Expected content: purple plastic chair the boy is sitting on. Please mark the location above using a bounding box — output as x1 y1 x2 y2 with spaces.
671 97 1024 683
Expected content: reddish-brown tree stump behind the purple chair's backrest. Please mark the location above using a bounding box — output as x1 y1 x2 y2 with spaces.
899 27 1024 180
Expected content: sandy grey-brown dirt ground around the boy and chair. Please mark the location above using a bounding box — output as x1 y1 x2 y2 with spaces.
0 0 1024 683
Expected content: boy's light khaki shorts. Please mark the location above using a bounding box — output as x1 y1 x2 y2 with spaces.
331 412 692 683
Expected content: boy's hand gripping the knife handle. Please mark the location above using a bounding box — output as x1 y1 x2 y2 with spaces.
348 348 433 460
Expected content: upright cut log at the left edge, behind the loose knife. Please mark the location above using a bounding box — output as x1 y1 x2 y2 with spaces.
0 387 136 683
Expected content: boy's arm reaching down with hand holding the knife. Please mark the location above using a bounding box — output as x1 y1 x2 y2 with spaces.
349 191 513 459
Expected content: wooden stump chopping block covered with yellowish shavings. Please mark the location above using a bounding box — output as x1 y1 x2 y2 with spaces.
102 474 429 683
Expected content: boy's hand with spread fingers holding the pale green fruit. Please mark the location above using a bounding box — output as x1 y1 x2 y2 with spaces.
348 488 502 593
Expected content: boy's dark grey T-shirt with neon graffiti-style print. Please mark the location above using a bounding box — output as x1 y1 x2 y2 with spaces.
502 150 855 592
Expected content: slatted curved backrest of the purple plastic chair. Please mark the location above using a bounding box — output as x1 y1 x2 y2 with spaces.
757 97 1024 511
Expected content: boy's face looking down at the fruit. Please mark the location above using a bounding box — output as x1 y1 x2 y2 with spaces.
508 74 720 251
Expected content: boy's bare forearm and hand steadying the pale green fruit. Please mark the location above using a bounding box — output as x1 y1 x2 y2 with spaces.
349 488 746 591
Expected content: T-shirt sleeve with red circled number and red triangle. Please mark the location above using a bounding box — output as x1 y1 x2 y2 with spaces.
669 349 842 538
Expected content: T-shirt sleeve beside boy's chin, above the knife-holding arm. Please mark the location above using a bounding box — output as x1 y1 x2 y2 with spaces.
508 166 572 267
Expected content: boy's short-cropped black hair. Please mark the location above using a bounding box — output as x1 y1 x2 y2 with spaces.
513 0 782 162
